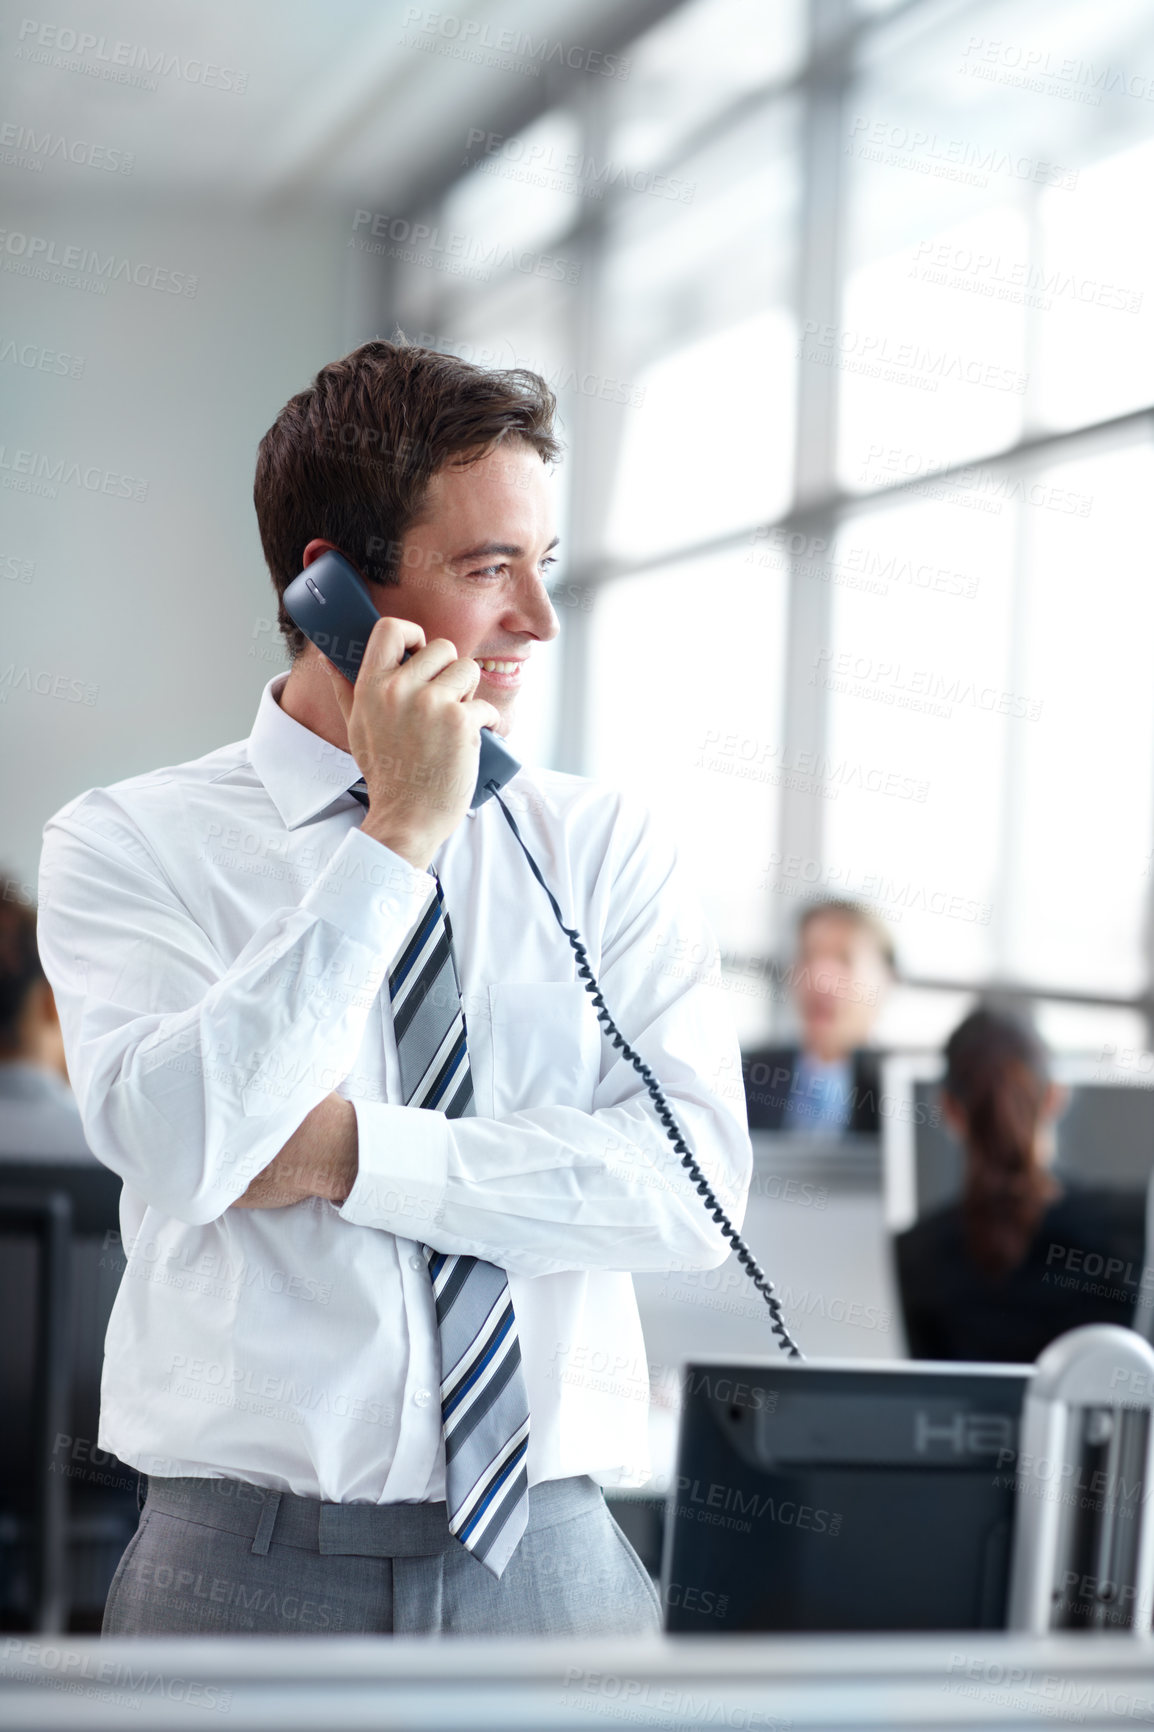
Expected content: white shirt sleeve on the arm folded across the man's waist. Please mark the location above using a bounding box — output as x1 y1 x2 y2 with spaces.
341 793 752 1275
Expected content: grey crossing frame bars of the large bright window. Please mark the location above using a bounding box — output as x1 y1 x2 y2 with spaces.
374 0 1154 1050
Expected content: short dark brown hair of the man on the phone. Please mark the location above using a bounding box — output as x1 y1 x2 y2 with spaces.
253 339 561 658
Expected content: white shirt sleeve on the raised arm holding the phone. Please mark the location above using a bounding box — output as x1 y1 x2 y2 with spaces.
38 790 430 1223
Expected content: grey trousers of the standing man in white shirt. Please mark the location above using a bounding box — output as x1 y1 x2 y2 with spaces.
102 1476 660 1635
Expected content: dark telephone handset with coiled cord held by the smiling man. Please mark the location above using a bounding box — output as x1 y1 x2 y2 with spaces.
284 549 802 1360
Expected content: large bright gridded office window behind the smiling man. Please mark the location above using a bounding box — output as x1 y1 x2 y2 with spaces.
377 0 1154 1051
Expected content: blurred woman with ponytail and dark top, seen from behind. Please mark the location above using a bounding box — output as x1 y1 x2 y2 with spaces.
896 1010 1145 1365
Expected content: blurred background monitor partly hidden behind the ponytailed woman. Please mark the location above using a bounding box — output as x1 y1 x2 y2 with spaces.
882 1053 1154 1233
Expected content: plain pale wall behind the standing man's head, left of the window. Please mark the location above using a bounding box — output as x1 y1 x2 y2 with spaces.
0 193 350 894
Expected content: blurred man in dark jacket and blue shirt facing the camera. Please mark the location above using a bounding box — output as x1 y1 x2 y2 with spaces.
742 901 896 1136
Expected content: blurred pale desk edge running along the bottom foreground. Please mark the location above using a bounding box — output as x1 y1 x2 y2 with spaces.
0 1633 1154 1732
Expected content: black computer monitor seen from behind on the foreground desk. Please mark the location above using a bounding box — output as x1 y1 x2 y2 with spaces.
662 1356 1033 1635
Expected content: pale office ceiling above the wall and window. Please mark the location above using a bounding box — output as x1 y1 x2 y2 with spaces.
0 0 652 210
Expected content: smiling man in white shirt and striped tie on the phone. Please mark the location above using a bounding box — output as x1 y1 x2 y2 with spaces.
40 341 750 1635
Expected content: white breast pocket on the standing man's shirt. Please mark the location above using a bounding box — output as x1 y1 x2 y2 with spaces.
489 980 601 1119
